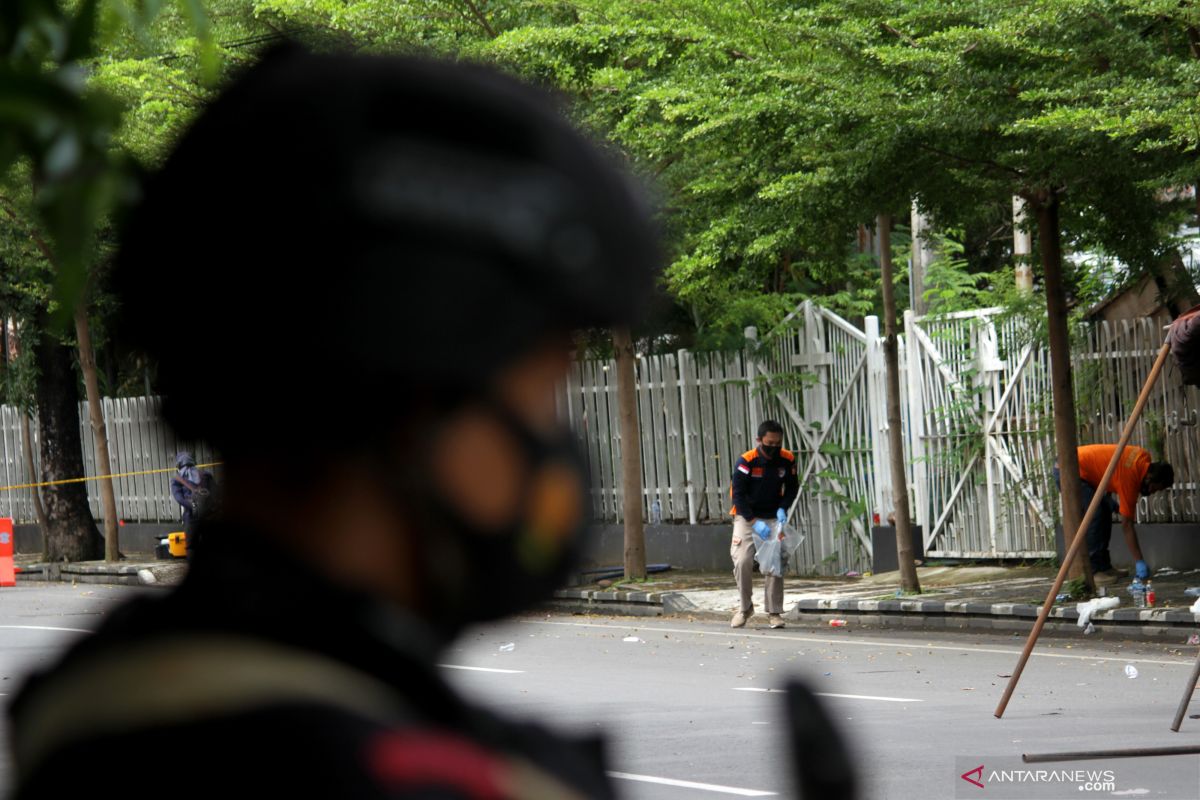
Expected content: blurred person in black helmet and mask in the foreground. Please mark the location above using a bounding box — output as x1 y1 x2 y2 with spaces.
7 47 660 800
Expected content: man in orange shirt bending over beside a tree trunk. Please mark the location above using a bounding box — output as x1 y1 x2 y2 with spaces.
1055 445 1175 585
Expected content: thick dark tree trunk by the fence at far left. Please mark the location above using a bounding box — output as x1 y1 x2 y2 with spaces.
36 320 103 561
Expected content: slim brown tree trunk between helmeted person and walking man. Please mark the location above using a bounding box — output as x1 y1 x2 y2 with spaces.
612 329 646 579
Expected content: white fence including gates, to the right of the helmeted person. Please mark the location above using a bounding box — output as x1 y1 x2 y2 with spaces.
560 302 1200 572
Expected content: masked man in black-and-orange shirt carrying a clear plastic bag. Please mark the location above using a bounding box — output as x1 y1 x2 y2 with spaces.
730 420 800 627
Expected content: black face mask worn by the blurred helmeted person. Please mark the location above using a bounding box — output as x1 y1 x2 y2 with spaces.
386 398 589 636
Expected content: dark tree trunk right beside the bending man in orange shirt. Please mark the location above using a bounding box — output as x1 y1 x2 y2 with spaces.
1026 191 1094 588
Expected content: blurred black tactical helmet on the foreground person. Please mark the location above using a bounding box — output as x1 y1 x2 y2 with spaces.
115 46 658 455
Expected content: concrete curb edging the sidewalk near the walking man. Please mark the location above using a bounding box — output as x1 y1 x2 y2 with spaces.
552 589 1200 643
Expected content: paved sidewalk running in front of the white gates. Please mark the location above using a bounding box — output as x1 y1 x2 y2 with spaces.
554 566 1200 644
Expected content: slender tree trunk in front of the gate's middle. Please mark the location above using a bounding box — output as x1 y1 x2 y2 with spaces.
876 213 920 593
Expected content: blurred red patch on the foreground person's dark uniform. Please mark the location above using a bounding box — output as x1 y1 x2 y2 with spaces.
367 733 508 800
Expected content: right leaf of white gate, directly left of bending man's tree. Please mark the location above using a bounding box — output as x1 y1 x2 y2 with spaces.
905 308 1055 558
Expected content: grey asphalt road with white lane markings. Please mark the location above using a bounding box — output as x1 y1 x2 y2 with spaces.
0 584 1200 800
